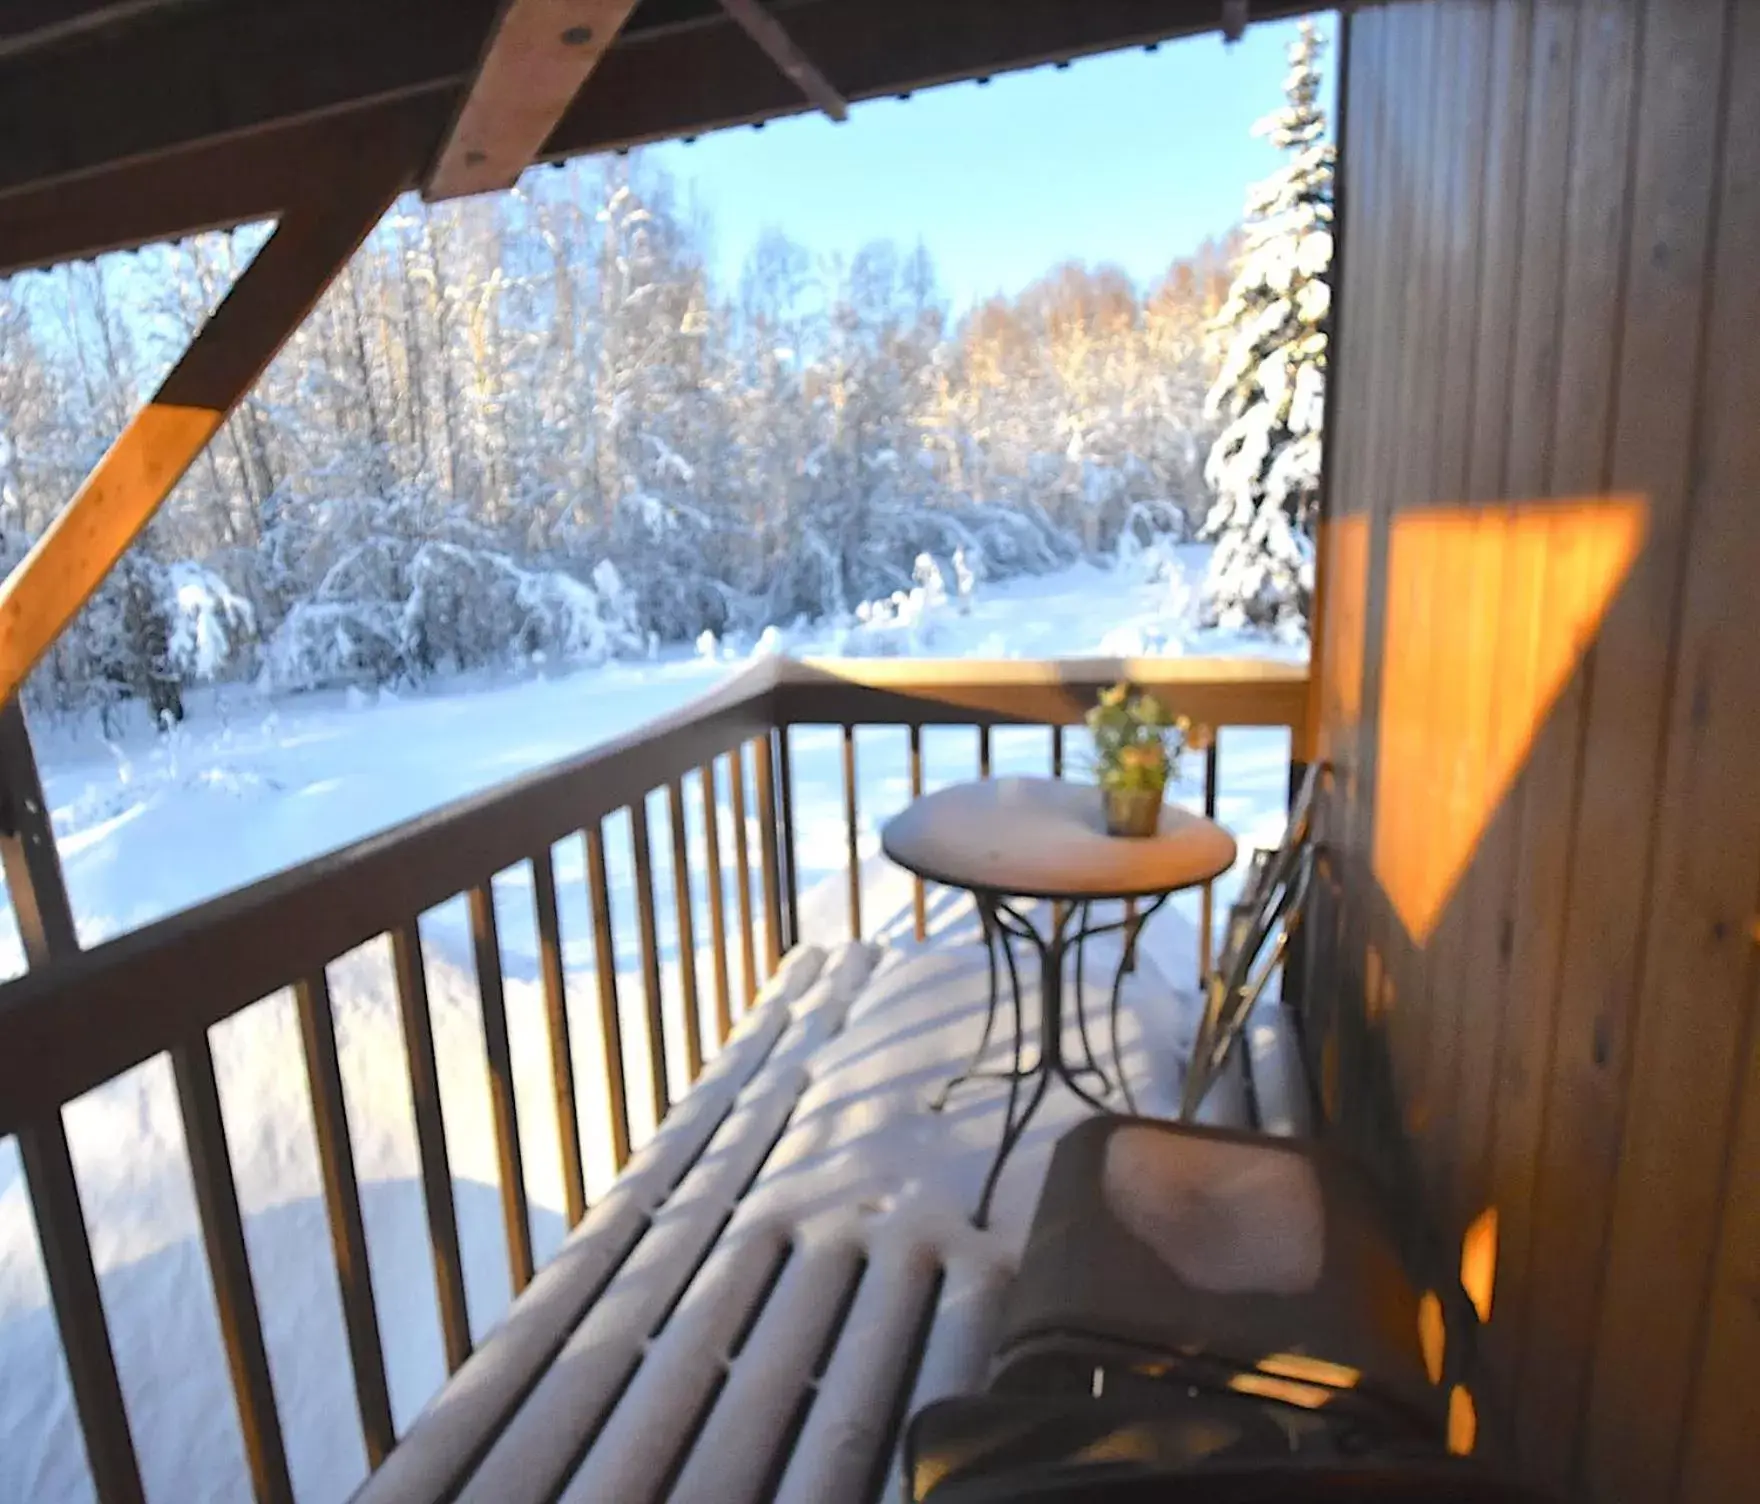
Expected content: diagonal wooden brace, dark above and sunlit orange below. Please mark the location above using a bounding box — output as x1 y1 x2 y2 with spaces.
0 120 419 700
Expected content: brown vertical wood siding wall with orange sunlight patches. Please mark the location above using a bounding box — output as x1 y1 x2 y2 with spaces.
1315 0 1760 1504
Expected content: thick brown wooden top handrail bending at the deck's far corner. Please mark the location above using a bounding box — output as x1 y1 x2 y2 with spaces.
0 658 1308 1135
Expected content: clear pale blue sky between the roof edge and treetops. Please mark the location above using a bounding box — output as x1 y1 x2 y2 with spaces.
649 21 1336 310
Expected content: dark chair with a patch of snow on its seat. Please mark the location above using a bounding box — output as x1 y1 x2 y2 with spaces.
996 1117 1443 1442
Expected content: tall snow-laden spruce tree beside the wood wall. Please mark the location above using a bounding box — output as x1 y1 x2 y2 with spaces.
1204 21 1336 630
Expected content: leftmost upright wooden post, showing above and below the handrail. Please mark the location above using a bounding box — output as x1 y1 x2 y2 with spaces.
0 698 144 1504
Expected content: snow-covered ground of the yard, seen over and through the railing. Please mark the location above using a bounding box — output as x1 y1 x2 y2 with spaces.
0 554 1297 1504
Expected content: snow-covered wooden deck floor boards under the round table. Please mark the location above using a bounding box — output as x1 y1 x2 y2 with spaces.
359 893 1295 1504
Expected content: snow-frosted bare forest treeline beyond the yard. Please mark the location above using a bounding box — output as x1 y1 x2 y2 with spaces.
0 155 1234 716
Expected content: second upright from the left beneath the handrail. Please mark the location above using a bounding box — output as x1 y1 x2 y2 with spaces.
171 1033 294 1504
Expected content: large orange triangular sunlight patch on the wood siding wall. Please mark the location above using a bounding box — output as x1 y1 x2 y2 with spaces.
1375 496 1649 945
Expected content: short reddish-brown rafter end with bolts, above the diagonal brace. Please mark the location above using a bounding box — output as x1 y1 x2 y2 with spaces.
428 0 637 199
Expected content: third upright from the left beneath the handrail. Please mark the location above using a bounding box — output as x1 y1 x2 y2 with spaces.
294 971 398 1467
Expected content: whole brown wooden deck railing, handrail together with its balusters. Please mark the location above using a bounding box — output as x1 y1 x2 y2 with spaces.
0 660 1306 1500
